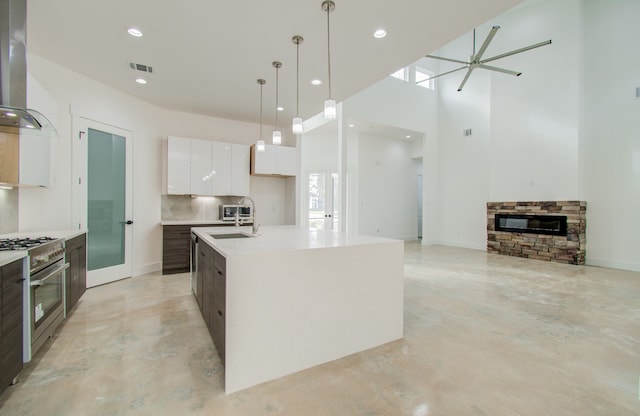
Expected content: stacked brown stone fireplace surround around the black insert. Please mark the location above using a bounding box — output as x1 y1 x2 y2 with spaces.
487 201 587 265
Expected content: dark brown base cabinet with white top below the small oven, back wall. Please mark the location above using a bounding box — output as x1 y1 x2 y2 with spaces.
162 222 252 274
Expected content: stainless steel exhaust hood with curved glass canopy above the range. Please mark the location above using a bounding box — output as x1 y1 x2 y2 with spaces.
0 0 56 135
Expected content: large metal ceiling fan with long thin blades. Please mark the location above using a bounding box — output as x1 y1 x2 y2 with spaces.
416 26 551 91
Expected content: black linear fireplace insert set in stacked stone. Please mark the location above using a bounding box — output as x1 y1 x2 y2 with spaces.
495 214 567 236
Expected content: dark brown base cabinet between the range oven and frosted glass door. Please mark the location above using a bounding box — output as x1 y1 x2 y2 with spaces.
65 234 87 314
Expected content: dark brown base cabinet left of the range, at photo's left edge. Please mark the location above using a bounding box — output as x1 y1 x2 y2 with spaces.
0 260 24 394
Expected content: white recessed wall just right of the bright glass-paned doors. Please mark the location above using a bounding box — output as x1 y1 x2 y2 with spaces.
354 134 418 240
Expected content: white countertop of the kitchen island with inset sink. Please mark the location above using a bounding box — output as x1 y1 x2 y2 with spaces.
191 225 396 257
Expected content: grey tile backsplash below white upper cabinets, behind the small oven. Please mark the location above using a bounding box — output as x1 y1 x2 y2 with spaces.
161 195 241 221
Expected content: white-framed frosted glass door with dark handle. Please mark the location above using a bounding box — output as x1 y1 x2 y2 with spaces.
72 117 133 287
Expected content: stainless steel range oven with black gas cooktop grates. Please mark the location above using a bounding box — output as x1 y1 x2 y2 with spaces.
0 237 69 362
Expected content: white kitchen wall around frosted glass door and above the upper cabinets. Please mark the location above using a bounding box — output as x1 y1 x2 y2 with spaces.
20 55 285 275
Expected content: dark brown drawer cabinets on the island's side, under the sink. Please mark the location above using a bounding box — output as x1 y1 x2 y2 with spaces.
197 244 227 365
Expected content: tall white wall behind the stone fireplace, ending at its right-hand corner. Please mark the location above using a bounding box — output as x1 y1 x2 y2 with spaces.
434 0 580 249
